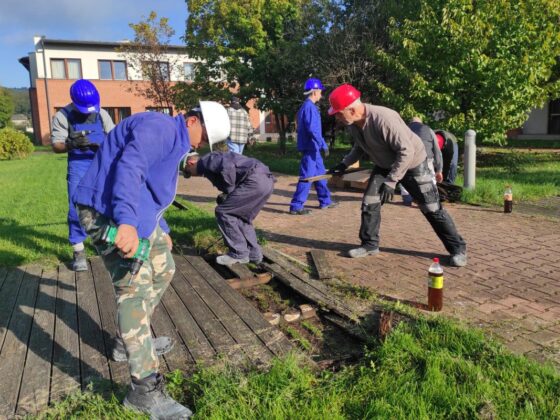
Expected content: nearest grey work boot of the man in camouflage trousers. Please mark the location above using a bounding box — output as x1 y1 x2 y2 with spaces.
123 373 192 420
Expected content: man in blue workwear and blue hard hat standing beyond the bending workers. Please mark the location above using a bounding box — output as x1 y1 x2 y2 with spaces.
290 78 338 215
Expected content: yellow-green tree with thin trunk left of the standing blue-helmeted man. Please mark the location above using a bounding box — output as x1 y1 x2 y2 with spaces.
184 0 323 150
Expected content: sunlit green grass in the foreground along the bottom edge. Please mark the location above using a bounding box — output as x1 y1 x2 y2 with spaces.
40 318 560 420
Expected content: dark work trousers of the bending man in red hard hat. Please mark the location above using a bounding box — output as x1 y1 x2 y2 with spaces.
360 161 466 255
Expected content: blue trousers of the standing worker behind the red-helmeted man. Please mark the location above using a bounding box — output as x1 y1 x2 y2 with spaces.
290 151 331 211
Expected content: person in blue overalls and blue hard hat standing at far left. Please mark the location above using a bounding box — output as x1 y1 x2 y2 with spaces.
51 79 115 271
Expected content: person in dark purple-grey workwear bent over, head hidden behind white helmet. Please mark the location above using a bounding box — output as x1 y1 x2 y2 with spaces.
184 152 275 265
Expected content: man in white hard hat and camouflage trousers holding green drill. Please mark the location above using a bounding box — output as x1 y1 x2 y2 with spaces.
74 101 229 419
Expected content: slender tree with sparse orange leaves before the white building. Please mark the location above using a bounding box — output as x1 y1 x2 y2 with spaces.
119 11 180 109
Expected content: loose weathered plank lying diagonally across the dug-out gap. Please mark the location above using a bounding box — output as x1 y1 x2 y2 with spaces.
264 263 357 320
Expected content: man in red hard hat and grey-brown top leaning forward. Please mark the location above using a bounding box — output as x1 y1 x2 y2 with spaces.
329 84 467 267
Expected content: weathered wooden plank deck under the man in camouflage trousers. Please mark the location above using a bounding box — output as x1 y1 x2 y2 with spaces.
0 255 291 419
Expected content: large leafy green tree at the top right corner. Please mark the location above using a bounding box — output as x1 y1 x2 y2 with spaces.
364 0 560 142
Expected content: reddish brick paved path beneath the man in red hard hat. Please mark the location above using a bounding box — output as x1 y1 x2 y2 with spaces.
179 175 560 366
